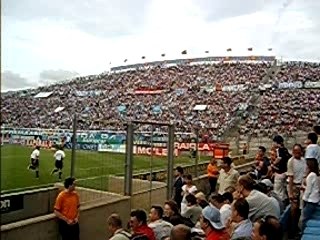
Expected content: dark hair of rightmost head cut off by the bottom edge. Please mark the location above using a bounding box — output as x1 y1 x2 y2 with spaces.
256 216 282 240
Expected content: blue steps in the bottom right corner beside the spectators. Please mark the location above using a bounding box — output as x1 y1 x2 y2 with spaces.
301 205 320 240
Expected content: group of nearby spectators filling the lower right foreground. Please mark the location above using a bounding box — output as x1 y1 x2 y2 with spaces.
95 129 320 240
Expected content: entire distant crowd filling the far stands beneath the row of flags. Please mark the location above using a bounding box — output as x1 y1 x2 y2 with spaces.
1 58 320 139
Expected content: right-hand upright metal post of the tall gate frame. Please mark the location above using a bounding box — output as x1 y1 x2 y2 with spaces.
167 124 174 199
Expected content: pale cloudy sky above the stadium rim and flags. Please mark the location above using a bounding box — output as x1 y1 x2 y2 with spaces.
1 0 320 91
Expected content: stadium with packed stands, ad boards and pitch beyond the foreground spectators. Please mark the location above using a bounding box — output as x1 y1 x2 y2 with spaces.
1 51 320 239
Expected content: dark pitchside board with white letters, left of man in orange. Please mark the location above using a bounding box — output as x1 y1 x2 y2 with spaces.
1 187 59 224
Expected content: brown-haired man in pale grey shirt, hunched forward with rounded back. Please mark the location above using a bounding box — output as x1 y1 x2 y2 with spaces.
236 175 278 222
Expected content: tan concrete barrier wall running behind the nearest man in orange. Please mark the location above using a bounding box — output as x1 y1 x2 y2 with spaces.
1 189 131 240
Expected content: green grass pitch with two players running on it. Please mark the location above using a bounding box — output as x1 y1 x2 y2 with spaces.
1 145 209 192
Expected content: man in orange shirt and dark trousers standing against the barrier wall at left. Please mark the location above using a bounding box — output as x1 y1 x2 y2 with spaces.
54 177 80 240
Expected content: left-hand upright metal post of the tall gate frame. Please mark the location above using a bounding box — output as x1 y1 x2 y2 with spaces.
124 122 133 196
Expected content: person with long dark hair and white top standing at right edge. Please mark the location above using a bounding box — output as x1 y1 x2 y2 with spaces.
302 158 320 231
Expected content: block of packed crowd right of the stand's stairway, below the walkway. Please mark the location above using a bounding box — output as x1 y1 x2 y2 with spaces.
240 90 320 136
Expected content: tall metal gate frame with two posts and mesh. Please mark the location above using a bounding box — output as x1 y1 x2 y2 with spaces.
124 121 174 207
